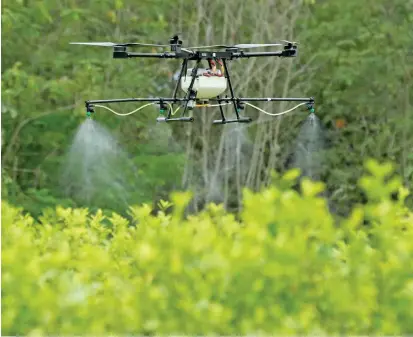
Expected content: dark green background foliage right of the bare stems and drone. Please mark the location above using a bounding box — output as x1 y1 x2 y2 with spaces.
298 0 413 214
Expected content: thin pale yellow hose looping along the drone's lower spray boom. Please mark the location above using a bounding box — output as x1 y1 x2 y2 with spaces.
86 102 315 118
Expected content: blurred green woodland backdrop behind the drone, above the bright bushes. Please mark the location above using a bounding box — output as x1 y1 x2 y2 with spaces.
1 0 413 216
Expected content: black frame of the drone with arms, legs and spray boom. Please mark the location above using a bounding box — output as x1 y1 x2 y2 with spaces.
85 36 314 124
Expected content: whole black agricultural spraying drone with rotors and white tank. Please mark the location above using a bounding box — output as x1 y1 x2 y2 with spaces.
71 35 314 124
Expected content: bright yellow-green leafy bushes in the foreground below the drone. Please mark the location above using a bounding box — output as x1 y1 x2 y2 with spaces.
2 161 413 335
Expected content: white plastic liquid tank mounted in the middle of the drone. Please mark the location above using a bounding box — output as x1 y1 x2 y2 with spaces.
181 69 227 99
